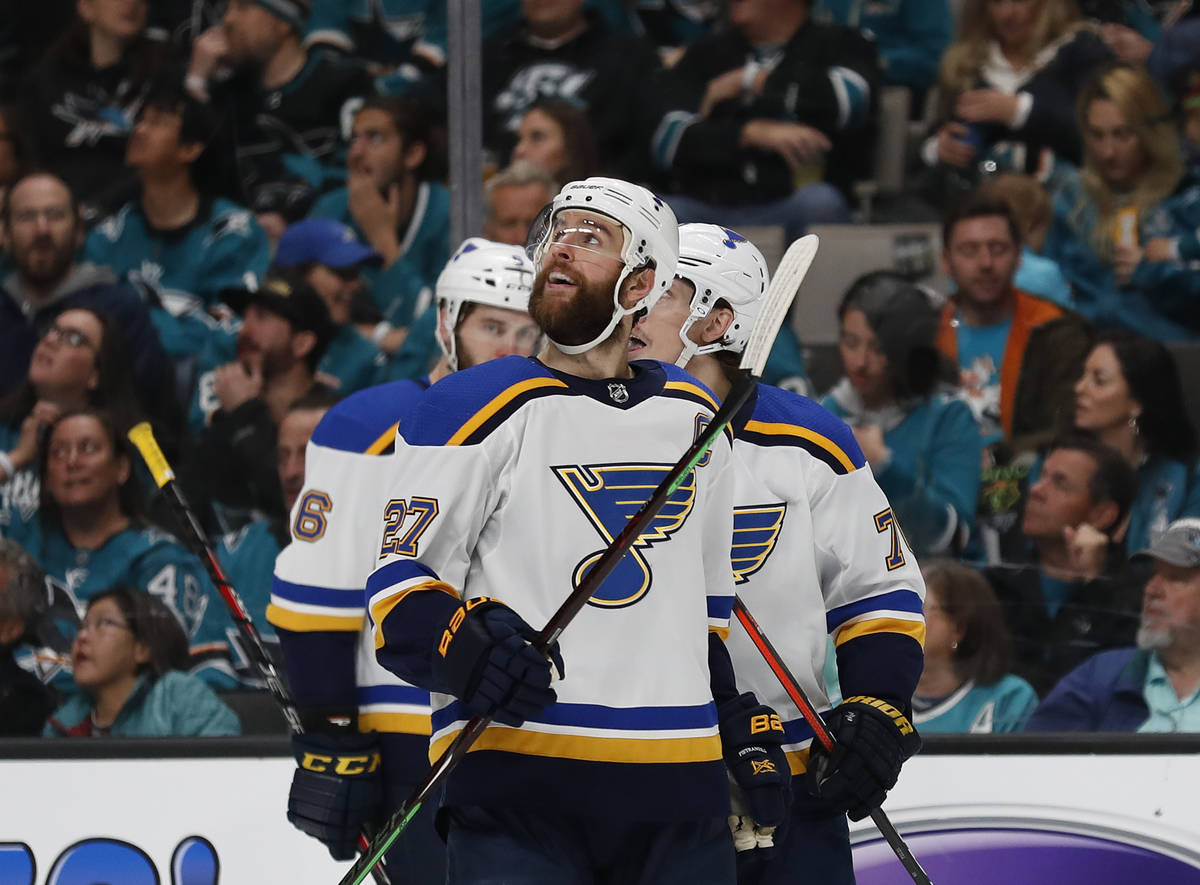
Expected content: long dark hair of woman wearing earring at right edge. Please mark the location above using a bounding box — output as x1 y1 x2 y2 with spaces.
1092 329 1198 463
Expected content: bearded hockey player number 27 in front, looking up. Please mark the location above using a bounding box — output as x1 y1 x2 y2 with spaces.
367 179 790 885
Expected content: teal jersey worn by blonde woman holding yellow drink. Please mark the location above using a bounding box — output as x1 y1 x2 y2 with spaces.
1044 165 1200 342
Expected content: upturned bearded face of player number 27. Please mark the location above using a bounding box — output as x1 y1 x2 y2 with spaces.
529 209 625 345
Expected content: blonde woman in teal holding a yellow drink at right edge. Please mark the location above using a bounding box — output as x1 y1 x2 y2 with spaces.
1045 65 1200 341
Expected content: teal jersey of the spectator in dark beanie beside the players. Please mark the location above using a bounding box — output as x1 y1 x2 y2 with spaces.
821 379 983 555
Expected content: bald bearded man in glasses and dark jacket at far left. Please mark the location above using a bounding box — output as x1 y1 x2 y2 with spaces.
0 173 175 411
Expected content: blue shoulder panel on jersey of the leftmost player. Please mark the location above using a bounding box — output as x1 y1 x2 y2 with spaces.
312 378 428 454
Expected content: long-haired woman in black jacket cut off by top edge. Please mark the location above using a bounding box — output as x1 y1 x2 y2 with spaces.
922 0 1111 193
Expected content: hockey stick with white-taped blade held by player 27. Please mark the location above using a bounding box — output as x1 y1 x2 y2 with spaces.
338 235 818 885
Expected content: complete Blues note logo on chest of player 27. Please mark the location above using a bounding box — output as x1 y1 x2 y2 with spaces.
552 464 696 608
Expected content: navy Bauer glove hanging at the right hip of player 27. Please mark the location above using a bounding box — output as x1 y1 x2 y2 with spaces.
716 692 792 848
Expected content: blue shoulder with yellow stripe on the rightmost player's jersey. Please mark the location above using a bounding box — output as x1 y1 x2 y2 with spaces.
738 384 866 475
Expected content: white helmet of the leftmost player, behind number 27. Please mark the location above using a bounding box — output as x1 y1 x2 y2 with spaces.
434 236 533 372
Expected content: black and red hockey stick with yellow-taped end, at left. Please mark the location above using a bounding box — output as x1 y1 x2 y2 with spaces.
128 421 391 885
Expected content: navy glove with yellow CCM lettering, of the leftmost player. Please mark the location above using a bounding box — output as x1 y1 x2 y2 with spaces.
288 733 383 860
